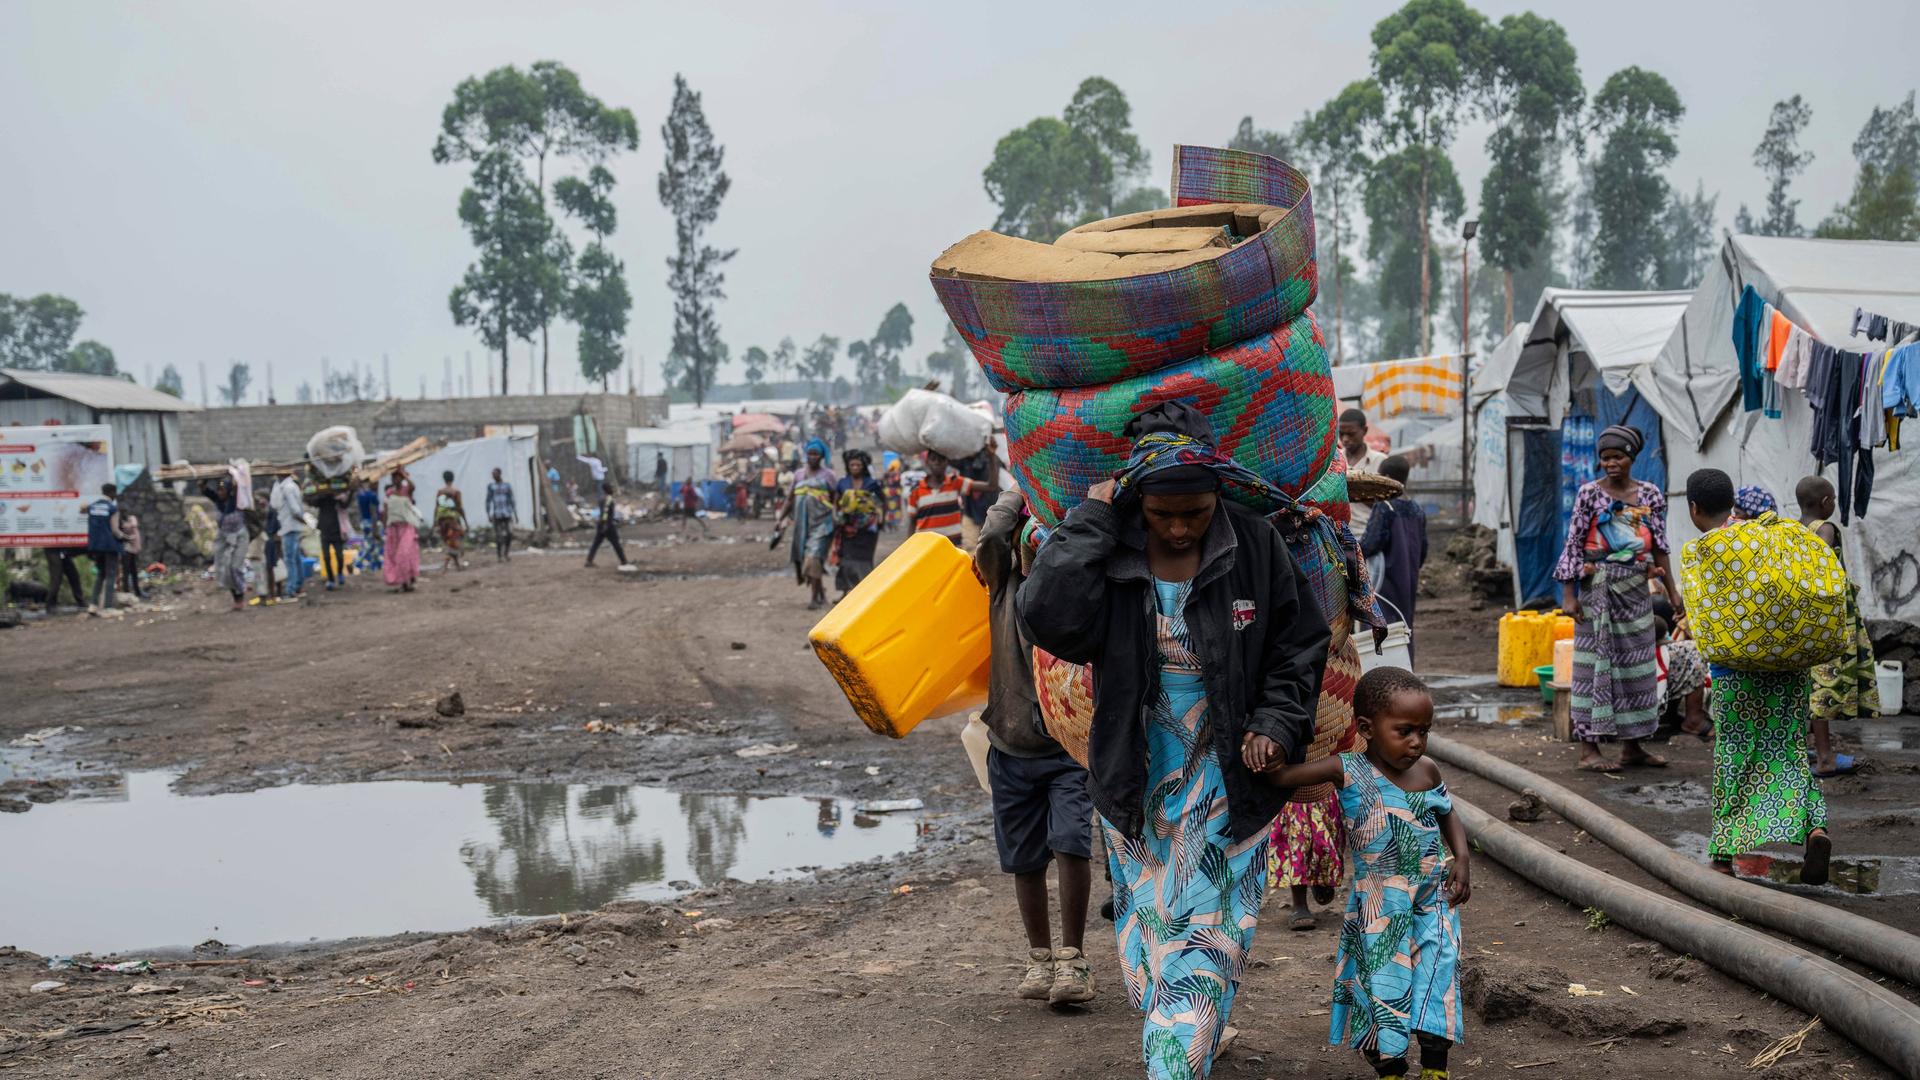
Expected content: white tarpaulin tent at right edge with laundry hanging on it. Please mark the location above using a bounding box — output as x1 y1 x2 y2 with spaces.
1634 236 1920 623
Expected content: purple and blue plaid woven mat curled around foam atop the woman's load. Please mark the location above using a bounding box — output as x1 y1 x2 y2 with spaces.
933 146 1319 392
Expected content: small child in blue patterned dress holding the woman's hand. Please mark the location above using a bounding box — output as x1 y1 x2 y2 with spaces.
1265 667 1473 1080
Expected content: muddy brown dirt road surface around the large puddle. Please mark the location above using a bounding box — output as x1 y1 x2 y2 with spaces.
0 525 1920 1078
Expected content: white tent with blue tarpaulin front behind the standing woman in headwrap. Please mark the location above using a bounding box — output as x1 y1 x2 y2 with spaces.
1469 288 1693 603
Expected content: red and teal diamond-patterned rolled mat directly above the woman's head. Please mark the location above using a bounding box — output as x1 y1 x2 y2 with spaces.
1006 315 1346 528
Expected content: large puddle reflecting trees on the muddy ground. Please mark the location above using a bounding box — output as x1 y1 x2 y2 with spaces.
0 773 916 955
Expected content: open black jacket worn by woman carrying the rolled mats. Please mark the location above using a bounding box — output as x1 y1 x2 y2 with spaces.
1018 500 1331 842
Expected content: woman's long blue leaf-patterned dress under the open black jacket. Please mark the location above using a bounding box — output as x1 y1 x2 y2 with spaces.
1100 580 1267 1080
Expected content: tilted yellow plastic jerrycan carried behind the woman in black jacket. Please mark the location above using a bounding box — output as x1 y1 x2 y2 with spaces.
808 532 991 738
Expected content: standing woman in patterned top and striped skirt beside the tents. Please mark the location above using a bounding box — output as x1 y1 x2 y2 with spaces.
1553 425 1686 773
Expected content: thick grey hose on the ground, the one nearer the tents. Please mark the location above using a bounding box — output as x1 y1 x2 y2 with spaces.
1427 736 1920 986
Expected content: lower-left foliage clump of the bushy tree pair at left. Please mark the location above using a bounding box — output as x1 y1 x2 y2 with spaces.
447 152 553 394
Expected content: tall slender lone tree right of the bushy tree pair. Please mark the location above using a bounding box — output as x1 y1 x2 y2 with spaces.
660 75 735 404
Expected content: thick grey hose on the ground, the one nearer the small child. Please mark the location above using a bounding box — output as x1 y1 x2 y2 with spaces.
1453 796 1920 1080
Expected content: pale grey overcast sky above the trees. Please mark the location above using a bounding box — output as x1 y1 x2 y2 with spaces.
0 0 1920 402
